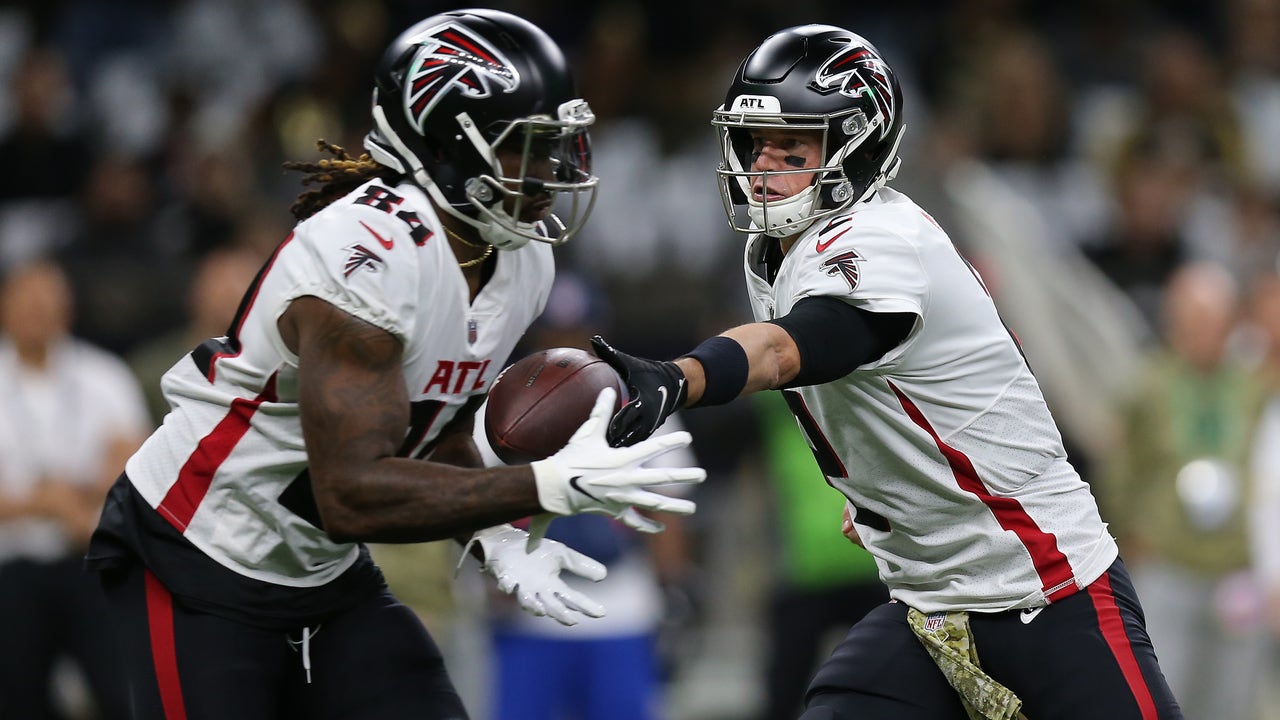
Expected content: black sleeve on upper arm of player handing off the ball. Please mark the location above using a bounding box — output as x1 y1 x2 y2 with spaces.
769 296 916 388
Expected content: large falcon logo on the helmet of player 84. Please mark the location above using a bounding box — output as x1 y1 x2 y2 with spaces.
404 23 520 132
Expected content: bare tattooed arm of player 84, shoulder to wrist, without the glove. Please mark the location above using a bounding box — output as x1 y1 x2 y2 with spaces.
279 297 541 542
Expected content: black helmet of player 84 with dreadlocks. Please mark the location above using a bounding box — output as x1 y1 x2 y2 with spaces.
365 9 598 250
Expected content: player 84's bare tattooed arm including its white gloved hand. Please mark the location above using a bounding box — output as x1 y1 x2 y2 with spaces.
279 297 705 542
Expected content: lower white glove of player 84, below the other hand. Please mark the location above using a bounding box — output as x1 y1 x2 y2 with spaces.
463 525 607 625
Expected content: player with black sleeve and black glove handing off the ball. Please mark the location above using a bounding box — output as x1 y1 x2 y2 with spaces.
594 26 1181 720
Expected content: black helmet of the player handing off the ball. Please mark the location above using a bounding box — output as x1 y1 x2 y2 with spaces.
712 24 906 237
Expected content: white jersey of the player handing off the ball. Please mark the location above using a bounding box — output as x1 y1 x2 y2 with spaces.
746 188 1117 612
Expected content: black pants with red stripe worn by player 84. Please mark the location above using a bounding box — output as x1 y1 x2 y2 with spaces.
102 565 467 720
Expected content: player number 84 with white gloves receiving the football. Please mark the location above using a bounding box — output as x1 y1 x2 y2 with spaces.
88 9 704 720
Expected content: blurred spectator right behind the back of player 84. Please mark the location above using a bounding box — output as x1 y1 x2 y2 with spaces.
128 249 262 425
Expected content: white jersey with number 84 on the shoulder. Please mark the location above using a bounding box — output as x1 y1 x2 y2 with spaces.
127 181 554 587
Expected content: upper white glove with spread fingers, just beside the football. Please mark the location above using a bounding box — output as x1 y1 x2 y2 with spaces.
531 388 707 533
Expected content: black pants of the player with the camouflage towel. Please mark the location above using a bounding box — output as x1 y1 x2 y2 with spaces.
801 560 1183 720
